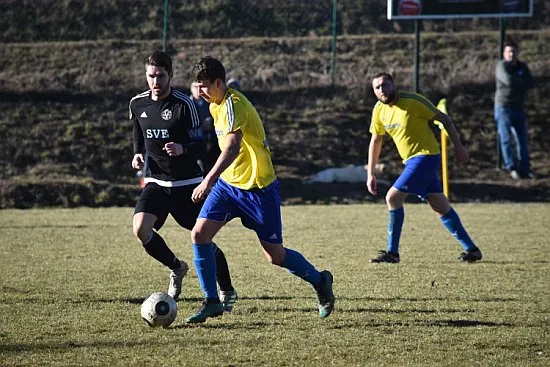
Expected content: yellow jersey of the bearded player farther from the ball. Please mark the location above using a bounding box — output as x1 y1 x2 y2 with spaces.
369 92 440 162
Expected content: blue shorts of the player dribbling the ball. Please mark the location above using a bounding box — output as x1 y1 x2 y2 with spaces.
199 179 283 245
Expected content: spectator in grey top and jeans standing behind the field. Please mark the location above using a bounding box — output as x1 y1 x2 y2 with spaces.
495 41 534 180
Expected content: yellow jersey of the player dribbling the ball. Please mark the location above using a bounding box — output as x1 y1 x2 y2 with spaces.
210 88 276 190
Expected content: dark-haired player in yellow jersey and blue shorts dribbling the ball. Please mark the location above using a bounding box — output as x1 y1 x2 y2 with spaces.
186 56 334 323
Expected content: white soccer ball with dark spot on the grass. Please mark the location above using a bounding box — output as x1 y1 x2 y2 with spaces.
141 292 178 327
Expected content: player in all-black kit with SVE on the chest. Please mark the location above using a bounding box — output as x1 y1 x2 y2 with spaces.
130 51 237 311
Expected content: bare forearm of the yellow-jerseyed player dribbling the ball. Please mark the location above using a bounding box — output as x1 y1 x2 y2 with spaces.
191 130 243 203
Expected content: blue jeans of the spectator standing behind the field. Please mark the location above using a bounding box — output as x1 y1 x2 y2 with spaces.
495 106 531 174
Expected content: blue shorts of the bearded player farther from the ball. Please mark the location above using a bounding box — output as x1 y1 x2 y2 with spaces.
393 154 443 200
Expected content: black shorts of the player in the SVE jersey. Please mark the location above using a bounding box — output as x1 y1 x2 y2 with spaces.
134 183 203 230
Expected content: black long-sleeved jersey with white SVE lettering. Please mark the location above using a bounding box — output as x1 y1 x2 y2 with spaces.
130 88 203 186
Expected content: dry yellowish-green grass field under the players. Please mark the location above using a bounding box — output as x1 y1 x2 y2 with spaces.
0 203 550 366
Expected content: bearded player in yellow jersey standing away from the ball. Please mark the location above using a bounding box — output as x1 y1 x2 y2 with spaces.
367 73 482 263
